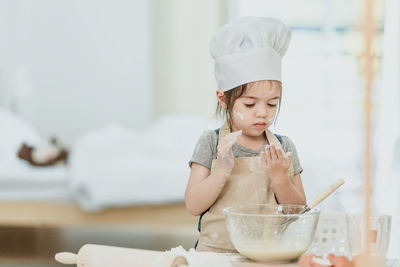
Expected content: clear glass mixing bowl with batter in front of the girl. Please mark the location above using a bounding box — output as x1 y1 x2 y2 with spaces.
223 204 320 262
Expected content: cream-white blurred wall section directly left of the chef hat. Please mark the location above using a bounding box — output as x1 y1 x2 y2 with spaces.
153 0 227 117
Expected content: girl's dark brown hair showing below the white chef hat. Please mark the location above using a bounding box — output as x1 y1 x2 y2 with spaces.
215 80 282 131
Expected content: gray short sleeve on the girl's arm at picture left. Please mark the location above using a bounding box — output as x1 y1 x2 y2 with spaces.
189 130 218 170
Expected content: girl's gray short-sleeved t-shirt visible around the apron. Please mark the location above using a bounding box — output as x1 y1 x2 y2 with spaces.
189 130 303 175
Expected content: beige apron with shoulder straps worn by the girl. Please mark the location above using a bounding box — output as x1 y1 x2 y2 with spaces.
196 123 294 252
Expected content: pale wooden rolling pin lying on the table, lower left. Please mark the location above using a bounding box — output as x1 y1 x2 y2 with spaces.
55 244 189 267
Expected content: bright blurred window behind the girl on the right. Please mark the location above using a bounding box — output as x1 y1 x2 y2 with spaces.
229 0 383 214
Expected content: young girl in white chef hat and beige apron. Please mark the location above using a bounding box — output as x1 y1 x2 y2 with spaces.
185 17 306 252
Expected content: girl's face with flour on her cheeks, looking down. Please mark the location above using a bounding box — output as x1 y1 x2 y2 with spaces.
231 81 281 136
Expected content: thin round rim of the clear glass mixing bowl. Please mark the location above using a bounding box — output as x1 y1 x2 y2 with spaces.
222 204 321 218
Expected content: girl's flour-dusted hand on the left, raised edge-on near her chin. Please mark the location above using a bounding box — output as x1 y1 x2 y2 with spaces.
217 130 242 176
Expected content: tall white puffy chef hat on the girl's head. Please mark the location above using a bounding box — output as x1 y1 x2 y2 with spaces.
210 17 291 91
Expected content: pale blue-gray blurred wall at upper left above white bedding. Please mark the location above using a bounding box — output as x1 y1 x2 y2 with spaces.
0 0 152 143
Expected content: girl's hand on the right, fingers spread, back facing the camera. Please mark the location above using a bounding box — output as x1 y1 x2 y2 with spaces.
260 144 292 182
